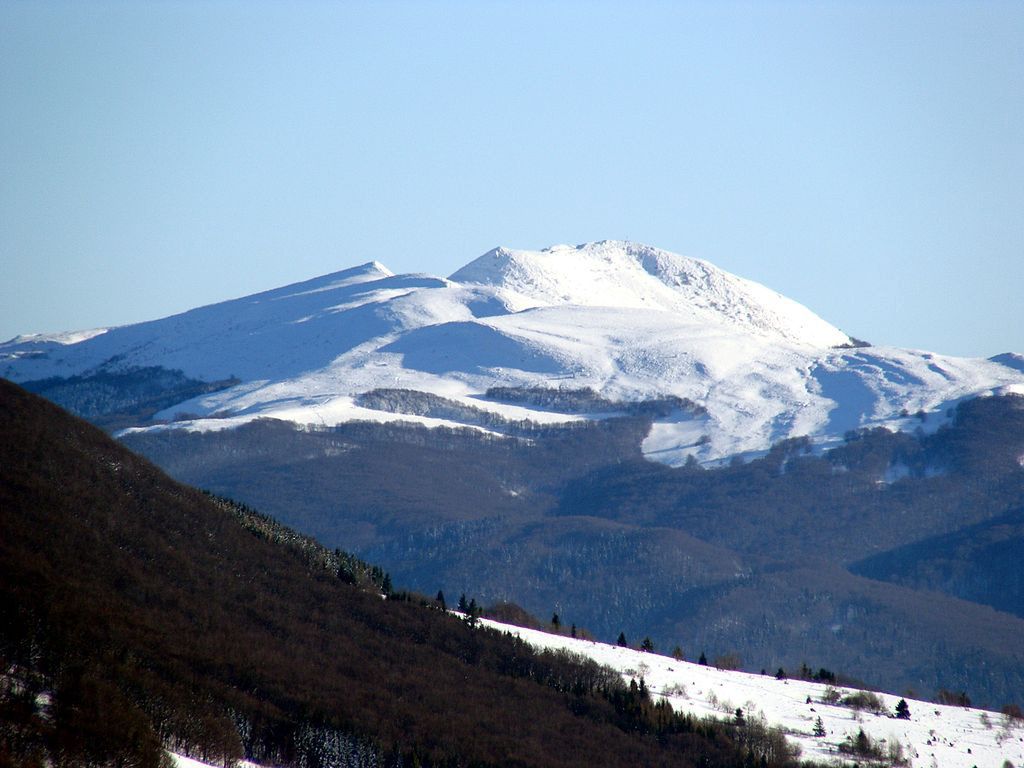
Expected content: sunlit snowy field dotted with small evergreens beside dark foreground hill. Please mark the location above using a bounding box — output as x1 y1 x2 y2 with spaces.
481 620 1024 768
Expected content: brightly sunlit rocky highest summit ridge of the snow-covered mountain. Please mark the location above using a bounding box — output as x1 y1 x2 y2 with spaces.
450 240 850 347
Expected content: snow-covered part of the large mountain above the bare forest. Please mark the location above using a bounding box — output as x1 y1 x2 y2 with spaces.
0 242 1024 464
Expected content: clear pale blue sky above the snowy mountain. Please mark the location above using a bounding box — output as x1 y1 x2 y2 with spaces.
0 0 1024 356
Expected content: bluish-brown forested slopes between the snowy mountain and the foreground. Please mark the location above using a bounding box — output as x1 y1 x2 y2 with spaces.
124 388 1024 707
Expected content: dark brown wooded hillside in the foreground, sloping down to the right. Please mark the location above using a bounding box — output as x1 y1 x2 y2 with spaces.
0 381 815 768
